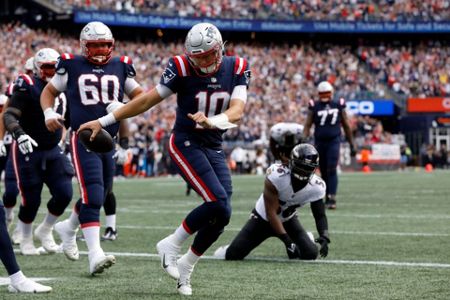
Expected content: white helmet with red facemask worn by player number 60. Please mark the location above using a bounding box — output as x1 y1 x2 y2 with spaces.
80 22 114 65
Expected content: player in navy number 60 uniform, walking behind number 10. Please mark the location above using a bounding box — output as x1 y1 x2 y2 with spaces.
41 22 143 275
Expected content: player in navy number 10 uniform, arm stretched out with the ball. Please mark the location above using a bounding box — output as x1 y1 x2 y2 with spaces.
76 23 250 295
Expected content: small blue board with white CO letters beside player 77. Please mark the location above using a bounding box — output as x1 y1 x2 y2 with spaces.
346 99 394 116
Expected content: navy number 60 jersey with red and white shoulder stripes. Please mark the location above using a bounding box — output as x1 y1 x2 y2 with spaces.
51 53 139 136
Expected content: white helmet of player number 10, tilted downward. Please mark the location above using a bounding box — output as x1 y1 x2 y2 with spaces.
184 23 224 75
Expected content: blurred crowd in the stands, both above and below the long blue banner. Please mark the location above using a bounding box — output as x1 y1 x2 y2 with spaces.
0 0 450 176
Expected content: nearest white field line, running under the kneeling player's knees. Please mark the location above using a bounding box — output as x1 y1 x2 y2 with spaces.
75 251 450 268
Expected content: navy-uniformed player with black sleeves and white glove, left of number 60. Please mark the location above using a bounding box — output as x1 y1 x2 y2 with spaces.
3 48 73 255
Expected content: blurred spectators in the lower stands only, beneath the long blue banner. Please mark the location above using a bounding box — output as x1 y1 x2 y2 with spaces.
0 24 450 175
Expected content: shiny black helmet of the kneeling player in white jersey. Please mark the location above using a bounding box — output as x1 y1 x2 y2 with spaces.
289 144 319 181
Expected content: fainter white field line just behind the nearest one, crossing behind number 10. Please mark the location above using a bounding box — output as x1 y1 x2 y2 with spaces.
117 225 450 237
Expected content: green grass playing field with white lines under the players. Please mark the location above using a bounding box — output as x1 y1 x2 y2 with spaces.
0 171 450 300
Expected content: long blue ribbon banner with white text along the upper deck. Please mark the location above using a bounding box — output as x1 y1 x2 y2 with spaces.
74 10 450 33
